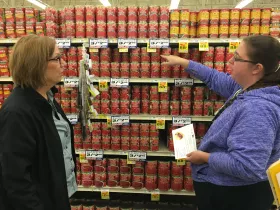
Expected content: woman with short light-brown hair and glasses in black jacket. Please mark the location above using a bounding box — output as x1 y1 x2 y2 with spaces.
0 35 77 210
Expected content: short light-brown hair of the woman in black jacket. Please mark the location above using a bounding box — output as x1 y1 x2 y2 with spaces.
9 35 56 89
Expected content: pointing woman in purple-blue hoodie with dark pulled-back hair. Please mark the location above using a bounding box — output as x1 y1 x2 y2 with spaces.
163 36 280 210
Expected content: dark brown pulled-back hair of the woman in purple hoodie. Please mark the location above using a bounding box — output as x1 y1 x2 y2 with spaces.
243 35 280 89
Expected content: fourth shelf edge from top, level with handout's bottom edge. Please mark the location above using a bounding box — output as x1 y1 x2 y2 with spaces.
76 143 175 157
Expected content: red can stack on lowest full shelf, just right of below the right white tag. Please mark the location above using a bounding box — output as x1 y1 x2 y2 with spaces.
145 160 158 191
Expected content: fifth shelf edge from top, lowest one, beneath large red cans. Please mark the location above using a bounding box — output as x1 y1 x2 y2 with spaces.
78 186 195 196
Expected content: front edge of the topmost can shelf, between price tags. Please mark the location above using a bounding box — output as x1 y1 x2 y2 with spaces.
0 38 280 44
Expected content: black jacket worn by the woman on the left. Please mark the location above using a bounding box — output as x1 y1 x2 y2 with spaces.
0 87 75 210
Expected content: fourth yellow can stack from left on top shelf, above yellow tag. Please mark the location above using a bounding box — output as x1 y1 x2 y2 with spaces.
197 9 210 38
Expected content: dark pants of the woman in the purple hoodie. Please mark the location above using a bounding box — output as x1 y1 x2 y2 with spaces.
194 181 274 210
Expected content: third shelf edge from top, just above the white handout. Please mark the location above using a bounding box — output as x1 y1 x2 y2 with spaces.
90 114 213 122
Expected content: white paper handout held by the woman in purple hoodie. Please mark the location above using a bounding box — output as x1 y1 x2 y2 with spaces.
172 124 197 159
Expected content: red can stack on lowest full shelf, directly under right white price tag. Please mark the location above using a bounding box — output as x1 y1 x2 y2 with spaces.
132 161 145 189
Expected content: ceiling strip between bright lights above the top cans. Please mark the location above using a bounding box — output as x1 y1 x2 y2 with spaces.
0 0 280 10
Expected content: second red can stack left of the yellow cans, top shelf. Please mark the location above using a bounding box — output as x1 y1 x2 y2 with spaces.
148 6 160 38
